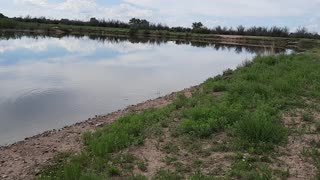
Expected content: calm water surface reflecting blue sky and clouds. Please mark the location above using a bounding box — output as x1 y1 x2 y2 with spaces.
0 36 288 145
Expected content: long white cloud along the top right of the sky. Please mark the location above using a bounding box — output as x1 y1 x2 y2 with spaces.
124 0 320 17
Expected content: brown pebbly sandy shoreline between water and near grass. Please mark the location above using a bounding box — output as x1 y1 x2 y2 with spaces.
0 86 197 179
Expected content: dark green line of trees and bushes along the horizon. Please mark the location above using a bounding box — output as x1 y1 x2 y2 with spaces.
0 13 320 39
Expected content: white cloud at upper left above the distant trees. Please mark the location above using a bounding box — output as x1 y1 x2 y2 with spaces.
10 0 152 20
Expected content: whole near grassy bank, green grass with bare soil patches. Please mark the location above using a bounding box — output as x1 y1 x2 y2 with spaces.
37 43 320 179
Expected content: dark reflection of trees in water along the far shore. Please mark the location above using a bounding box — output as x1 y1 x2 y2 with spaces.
0 32 286 54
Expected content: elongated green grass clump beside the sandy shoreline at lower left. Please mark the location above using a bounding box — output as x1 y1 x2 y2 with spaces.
84 106 173 157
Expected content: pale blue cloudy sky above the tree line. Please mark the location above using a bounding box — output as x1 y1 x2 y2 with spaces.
0 0 320 32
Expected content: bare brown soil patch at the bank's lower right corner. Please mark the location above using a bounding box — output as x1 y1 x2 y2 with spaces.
278 109 320 180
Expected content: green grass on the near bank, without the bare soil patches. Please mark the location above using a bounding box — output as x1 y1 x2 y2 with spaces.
39 45 320 179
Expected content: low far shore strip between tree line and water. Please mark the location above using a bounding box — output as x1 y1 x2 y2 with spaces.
0 27 300 49
